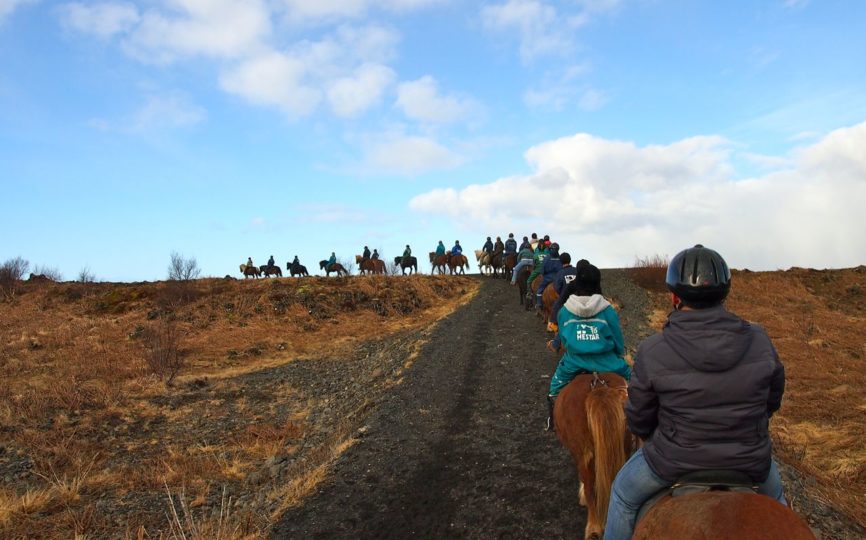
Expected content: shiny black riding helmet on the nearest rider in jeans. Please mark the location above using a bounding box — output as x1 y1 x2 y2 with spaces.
665 244 731 308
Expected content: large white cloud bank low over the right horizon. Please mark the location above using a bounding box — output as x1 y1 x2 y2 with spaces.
410 123 866 269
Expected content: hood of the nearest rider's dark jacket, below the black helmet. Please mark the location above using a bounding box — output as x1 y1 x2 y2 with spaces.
662 306 752 371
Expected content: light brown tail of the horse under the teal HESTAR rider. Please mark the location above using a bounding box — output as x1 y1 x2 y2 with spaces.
586 386 626 524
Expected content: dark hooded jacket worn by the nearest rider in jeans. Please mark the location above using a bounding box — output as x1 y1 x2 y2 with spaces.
626 306 785 482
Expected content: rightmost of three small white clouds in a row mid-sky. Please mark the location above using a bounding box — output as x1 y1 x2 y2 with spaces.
397 75 475 123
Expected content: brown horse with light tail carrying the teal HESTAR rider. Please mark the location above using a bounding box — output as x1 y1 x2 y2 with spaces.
553 373 635 540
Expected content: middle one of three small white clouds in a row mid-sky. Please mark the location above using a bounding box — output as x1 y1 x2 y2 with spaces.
328 64 397 117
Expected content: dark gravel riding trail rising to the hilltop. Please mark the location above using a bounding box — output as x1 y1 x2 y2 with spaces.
273 274 646 538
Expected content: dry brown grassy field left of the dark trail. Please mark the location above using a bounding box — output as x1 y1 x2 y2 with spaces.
0 276 477 538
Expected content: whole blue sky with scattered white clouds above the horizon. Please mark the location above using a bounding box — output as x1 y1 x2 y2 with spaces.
0 0 866 281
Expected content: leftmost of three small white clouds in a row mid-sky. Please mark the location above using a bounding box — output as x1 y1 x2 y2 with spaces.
220 52 322 117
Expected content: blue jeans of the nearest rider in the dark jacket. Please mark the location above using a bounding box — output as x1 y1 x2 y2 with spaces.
604 448 788 540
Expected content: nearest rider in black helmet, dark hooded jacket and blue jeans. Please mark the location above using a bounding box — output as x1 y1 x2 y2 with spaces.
605 245 786 540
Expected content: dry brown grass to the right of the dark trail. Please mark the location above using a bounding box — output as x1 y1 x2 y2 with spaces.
636 266 866 525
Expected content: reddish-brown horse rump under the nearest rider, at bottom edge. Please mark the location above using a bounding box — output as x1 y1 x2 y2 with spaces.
632 491 815 540
